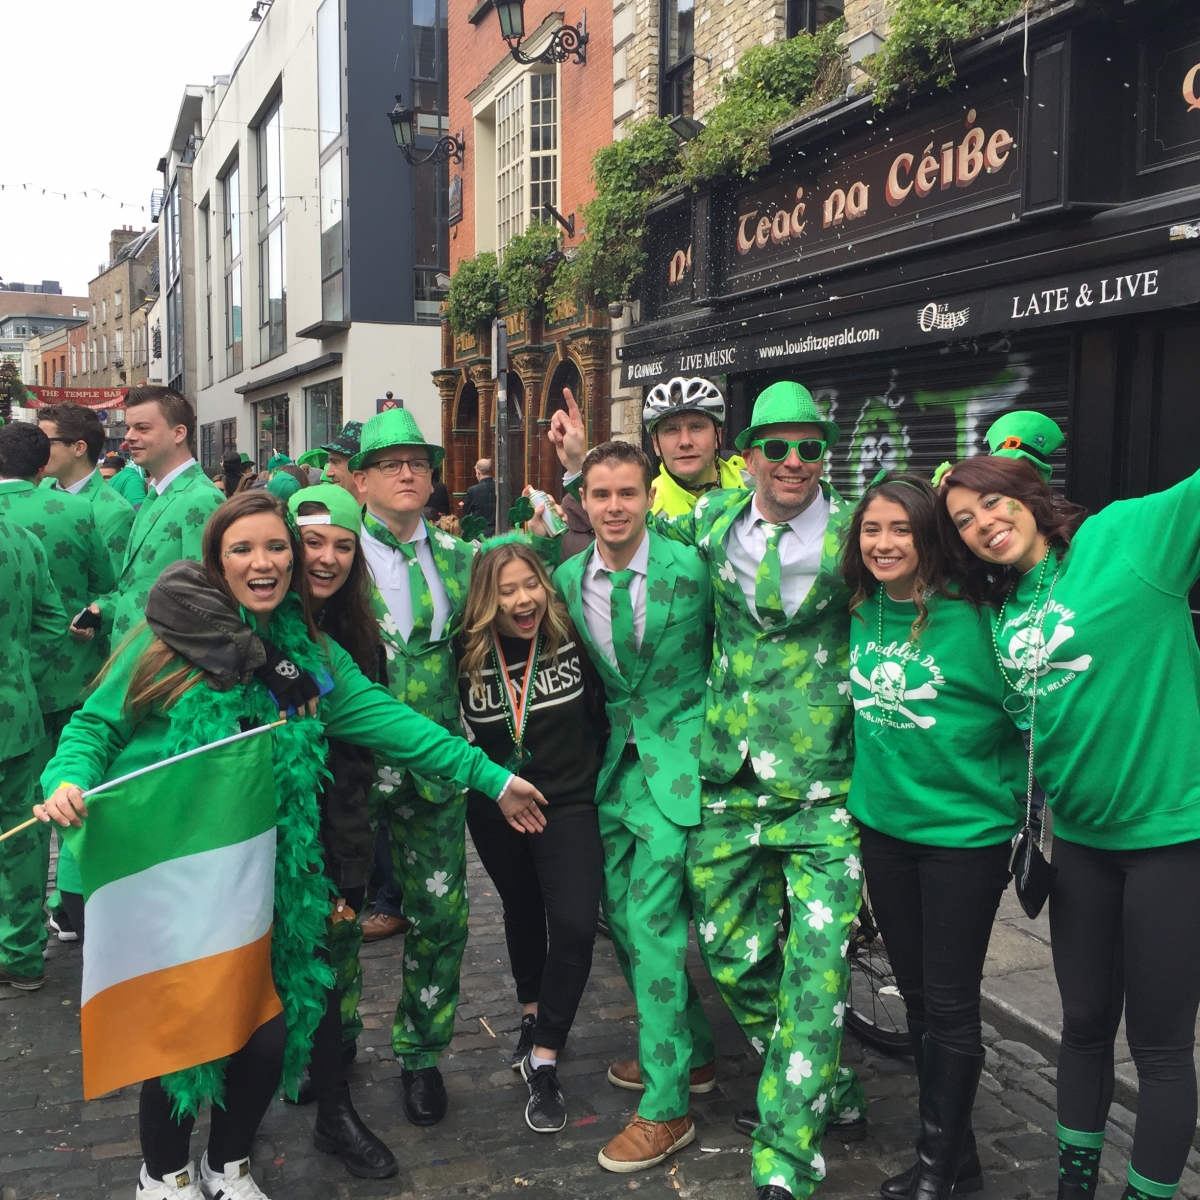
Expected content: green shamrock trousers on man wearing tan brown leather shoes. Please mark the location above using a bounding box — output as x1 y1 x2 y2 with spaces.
598 761 715 1121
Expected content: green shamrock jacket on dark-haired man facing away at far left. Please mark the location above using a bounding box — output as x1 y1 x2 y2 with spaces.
0 479 114 713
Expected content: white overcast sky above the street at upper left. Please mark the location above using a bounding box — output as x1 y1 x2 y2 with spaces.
0 0 257 295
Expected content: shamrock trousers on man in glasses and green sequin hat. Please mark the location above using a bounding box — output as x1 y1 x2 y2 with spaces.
372 777 467 1070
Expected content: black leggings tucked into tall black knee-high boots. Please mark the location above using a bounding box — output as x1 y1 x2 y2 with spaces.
862 826 1012 1054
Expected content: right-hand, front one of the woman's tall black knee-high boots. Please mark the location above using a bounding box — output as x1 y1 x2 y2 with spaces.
908 1038 984 1200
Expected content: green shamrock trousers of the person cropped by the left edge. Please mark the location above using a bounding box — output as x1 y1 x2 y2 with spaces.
0 750 50 978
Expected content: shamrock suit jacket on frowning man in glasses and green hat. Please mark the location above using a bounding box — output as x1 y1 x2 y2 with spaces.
371 523 475 802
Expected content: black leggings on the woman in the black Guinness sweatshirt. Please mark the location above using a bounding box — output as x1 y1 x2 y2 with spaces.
467 809 604 1050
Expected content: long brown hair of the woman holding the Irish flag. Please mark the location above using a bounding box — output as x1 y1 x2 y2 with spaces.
124 488 319 716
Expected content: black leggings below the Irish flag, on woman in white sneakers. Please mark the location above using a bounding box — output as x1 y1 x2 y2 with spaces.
138 1013 287 1180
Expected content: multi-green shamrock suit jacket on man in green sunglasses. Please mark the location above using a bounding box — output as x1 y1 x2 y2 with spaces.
652 480 854 803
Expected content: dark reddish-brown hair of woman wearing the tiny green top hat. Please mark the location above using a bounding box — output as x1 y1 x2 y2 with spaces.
937 455 1087 605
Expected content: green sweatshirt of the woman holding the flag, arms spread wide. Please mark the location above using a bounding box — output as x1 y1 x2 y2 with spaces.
42 630 510 797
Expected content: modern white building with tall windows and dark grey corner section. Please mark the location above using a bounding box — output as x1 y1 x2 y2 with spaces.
160 0 449 470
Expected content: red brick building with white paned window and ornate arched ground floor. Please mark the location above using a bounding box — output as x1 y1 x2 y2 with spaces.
436 0 612 496
